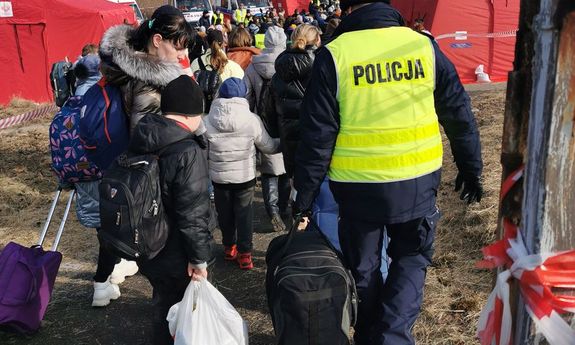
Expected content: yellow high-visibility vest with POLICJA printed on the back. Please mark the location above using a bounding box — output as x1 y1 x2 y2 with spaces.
327 27 443 183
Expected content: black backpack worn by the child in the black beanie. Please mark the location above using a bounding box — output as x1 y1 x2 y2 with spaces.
98 153 169 260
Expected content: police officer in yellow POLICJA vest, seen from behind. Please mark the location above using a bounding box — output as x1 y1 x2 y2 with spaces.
293 0 483 345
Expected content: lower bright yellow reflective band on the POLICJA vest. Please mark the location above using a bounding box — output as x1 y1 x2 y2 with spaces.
330 142 443 170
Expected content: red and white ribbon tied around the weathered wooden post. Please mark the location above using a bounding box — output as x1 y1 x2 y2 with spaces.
477 167 575 345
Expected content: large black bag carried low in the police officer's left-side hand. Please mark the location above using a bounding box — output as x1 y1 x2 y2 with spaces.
266 221 357 345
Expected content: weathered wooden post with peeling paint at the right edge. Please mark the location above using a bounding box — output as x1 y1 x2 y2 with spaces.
500 0 575 345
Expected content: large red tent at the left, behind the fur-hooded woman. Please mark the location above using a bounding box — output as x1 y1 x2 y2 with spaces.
0 0 135 104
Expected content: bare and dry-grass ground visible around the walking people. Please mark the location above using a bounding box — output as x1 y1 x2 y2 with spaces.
0 90 505 345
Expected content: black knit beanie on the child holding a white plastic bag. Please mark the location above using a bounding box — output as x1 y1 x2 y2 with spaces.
160 75 204 116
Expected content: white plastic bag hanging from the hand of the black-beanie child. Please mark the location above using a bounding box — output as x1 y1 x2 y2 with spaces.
166 279 248 345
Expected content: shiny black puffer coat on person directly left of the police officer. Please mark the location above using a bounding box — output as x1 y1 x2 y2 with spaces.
267 47 315 177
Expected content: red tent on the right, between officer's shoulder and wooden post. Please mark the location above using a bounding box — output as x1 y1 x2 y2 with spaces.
391 0 520 83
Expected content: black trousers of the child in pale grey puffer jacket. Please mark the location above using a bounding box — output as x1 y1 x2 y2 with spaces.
214 185 255 253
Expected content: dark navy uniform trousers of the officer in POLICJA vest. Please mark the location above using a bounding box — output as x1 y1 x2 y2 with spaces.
339 209 440 345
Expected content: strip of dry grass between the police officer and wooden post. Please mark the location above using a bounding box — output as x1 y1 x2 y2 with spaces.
415 91 505 345
